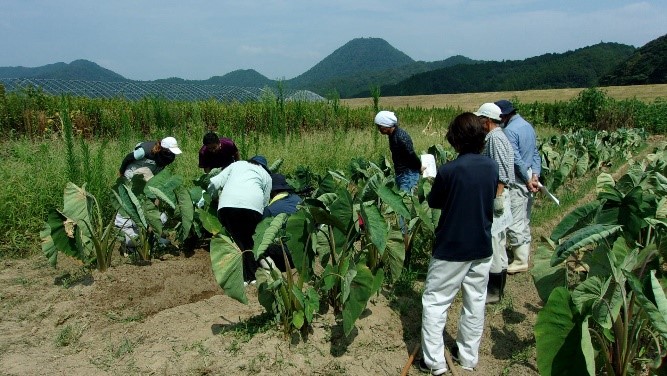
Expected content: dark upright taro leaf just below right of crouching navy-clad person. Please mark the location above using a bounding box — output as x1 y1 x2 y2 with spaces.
285 210 315 281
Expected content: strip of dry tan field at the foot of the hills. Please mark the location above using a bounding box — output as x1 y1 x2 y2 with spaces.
341 84 667 111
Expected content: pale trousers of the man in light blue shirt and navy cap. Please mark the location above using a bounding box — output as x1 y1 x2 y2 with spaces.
507 183 533 249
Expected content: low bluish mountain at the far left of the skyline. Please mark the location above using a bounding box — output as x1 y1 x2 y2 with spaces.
0 60 128 82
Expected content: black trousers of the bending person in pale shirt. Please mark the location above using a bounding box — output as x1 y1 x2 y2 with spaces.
218 208 262 282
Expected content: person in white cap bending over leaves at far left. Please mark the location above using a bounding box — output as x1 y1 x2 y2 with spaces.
114 137 182 254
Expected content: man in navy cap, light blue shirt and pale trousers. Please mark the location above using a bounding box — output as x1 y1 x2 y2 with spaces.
495 99 542 274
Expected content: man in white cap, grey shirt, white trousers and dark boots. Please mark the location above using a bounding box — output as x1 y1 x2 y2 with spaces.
474 103 514 304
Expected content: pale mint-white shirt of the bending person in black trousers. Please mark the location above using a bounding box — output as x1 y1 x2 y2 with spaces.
207 161 271 214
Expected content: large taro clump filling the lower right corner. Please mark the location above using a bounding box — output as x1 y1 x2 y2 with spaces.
532 151 667 375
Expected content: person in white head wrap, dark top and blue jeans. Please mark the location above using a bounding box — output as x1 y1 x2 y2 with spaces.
374 111 425 266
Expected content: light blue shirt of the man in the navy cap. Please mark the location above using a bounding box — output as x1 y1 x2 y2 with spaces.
503 114 542 183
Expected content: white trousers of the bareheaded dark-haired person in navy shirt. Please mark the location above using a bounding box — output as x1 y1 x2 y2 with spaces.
422 257 491 369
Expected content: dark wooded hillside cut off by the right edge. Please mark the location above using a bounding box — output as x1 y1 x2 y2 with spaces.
600 35 667 86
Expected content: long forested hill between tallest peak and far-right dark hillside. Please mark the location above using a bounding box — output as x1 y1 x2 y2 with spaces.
376 43 635 96
